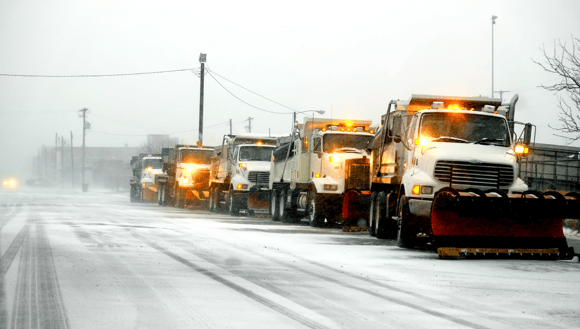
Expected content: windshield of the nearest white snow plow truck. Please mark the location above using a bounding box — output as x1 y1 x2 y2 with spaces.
420 112 511 146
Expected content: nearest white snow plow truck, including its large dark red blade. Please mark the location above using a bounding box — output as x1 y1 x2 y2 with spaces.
356 95 580 259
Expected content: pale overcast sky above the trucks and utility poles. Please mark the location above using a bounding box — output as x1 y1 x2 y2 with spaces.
0 0 580 177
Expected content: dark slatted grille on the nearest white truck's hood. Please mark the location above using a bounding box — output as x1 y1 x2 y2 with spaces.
435 161 514 188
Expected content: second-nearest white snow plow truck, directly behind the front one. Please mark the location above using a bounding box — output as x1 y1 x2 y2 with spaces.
269 117 374 227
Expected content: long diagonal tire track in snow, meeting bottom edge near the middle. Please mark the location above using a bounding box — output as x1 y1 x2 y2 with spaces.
131 231 327 328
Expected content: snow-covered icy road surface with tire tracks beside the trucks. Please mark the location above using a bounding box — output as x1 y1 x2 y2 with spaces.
0 189 580 329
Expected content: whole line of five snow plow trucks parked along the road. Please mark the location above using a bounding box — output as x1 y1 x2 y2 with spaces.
131 94 580 259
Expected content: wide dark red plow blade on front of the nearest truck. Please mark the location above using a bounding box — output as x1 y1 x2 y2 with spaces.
431 188 580 259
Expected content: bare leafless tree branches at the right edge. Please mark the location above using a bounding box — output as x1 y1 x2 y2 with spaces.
534 37 580 142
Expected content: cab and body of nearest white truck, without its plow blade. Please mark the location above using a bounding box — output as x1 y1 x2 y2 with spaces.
369 95 528 243
